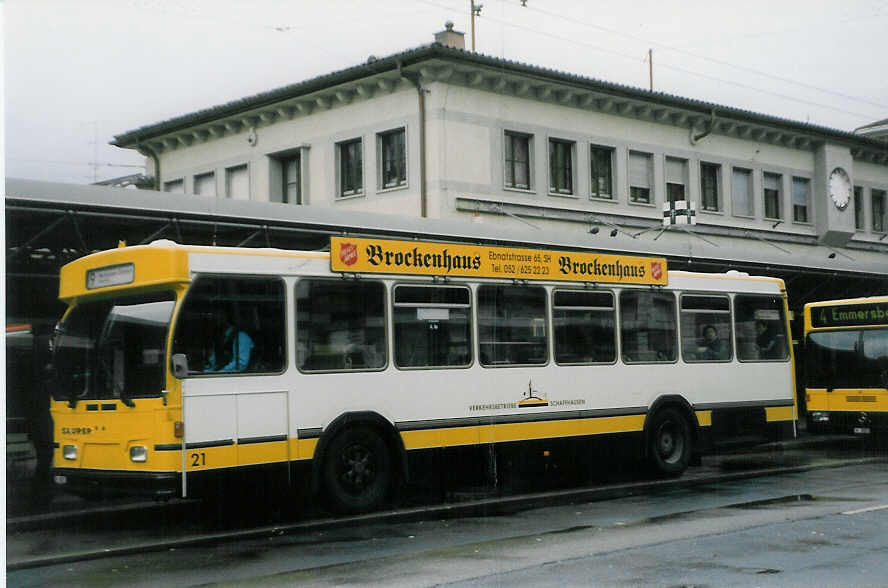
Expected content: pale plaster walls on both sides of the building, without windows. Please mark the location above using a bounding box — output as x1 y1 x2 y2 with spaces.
153 76 888 246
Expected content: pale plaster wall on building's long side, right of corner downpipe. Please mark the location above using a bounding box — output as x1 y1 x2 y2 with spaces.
427 83 844 235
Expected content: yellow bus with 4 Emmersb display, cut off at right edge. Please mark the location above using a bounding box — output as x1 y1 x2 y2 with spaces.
805 296 888 434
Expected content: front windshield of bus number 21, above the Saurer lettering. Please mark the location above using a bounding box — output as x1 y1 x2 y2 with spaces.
53 292 175 403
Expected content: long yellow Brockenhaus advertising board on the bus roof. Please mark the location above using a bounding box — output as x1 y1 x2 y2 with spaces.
330 237 668 286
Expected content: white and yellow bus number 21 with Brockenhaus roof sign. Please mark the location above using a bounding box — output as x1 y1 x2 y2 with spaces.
52 238 796 512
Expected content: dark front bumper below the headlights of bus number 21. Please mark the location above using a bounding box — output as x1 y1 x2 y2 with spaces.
52 468 181 499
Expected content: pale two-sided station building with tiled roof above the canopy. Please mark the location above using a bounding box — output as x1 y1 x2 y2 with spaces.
114 27 888 284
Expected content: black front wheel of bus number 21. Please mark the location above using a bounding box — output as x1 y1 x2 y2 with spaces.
322 426 392 513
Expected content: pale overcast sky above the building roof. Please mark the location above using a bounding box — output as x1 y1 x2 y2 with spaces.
2 0 888 183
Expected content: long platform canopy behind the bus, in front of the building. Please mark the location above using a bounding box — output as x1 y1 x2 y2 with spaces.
5 179 888 318
